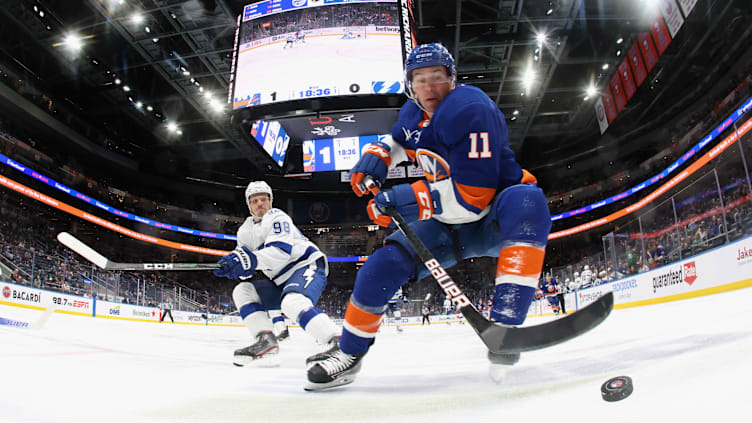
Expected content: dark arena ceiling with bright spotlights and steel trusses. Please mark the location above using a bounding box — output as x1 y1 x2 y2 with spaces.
0 0 752 195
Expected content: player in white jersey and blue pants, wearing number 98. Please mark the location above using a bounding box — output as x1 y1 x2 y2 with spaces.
214 181 340 367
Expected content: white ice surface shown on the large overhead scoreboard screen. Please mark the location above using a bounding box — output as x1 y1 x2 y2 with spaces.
234 34 403 102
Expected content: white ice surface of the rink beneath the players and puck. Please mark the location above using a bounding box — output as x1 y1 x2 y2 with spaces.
0 288 752 423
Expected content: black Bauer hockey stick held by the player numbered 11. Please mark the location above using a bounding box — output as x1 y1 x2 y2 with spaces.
363 177 614 354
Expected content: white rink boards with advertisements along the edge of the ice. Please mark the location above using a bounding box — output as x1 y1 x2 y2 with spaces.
0 237 752 326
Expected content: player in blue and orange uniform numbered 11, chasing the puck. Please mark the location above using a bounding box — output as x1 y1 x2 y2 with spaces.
307 43 551 390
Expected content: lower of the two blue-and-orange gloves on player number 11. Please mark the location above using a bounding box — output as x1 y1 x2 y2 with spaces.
368 181 441 227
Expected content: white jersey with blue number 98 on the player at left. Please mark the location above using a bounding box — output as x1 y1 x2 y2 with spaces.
238 208 329 285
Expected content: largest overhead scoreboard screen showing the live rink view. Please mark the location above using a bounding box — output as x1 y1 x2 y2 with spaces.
232 0 410 110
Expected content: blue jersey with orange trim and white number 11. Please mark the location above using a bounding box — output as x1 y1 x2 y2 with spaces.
392 85 523 224
